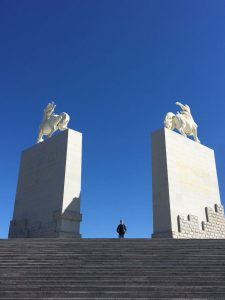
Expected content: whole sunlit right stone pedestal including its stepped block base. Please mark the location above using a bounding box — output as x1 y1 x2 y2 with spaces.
152 128 225 238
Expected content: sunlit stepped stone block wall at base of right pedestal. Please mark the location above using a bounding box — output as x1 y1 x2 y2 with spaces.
172 204 225 239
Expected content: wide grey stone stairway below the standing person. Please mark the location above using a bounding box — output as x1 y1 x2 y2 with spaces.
0 239 225 300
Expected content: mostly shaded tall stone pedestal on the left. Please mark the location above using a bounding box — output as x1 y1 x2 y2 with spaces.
9 129 82 238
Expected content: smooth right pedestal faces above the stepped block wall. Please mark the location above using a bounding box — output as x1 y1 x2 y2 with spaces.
152 128 221 237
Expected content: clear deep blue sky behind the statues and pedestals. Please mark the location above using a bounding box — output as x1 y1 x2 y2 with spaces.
0 0 225 238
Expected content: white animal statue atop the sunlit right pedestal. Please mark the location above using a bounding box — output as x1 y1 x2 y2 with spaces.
164 102 200 143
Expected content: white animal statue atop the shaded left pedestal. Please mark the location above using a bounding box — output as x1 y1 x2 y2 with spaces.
37 102 70 143
